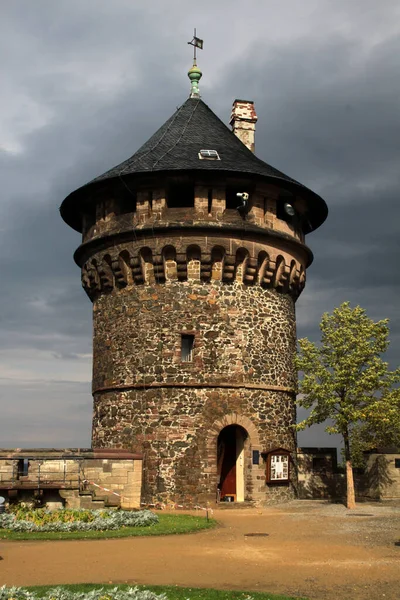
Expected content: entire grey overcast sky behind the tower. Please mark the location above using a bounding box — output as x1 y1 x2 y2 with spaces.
0 0 400 447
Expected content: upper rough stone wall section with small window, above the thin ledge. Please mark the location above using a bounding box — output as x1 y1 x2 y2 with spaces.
93 282 296 391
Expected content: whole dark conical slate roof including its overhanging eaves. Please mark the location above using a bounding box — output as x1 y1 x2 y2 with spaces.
60 97 328 232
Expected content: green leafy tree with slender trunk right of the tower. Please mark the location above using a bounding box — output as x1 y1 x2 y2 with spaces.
296 302 400 508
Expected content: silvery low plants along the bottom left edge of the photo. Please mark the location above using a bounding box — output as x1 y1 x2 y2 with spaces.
0 586 167 600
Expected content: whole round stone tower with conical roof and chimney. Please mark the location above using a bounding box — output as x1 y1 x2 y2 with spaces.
61 61 327 502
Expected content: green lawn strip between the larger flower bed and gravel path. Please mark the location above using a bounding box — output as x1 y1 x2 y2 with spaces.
0 513 217 540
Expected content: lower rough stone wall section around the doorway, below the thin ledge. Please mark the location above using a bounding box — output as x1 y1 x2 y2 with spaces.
93 388 295 502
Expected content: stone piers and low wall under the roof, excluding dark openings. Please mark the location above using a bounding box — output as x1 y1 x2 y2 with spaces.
82 179 305 242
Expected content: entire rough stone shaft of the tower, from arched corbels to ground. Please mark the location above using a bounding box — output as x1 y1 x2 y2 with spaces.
93 282 296 501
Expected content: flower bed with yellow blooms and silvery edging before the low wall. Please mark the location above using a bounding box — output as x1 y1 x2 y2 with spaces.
0 508 159 536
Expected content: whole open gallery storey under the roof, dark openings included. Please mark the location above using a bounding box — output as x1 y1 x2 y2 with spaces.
82 177 305 243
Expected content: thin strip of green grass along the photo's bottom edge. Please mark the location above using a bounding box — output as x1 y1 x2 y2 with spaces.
27 583 307 600
